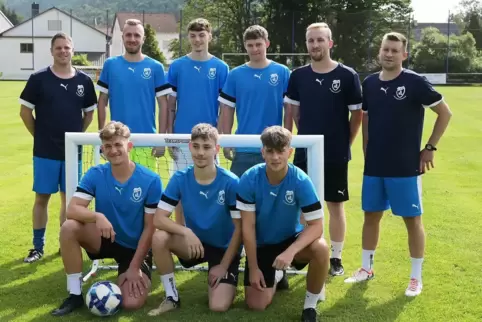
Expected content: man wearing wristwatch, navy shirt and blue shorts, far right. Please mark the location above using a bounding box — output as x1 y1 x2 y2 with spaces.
345 32 452 297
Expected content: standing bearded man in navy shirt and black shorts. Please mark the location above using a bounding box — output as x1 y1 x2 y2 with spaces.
285 23 362 276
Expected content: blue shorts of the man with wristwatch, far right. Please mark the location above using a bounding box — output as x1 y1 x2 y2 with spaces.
362 176 423 217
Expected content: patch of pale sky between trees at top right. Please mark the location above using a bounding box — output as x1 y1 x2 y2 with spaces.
412 0 460 22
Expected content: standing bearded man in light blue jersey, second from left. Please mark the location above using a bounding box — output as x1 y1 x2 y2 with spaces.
97 19 171 169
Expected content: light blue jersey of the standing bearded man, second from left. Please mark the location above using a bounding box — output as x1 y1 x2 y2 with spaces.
97 56 171 133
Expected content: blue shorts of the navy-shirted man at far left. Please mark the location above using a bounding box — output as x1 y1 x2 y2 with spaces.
32 157 82 194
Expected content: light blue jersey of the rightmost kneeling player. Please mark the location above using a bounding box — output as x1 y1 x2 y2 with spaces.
237 163 323 247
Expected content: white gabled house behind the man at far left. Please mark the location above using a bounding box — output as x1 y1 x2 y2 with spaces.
0 7 107 80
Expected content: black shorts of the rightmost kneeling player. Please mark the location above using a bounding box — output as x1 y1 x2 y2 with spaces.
244 234 308 287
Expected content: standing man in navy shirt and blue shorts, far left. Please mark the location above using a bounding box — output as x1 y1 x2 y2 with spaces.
20 33 97 263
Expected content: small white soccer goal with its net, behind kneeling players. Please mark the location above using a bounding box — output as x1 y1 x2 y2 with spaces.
65 133 324 282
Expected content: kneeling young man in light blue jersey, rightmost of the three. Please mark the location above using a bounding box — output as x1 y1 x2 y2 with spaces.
237 126 329 321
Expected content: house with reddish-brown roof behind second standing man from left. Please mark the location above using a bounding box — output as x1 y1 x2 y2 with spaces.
110 12 179 63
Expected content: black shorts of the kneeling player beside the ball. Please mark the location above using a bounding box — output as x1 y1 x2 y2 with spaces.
87 237 152 279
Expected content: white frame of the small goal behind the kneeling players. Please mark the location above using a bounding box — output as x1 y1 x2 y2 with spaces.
65 132 324 281
